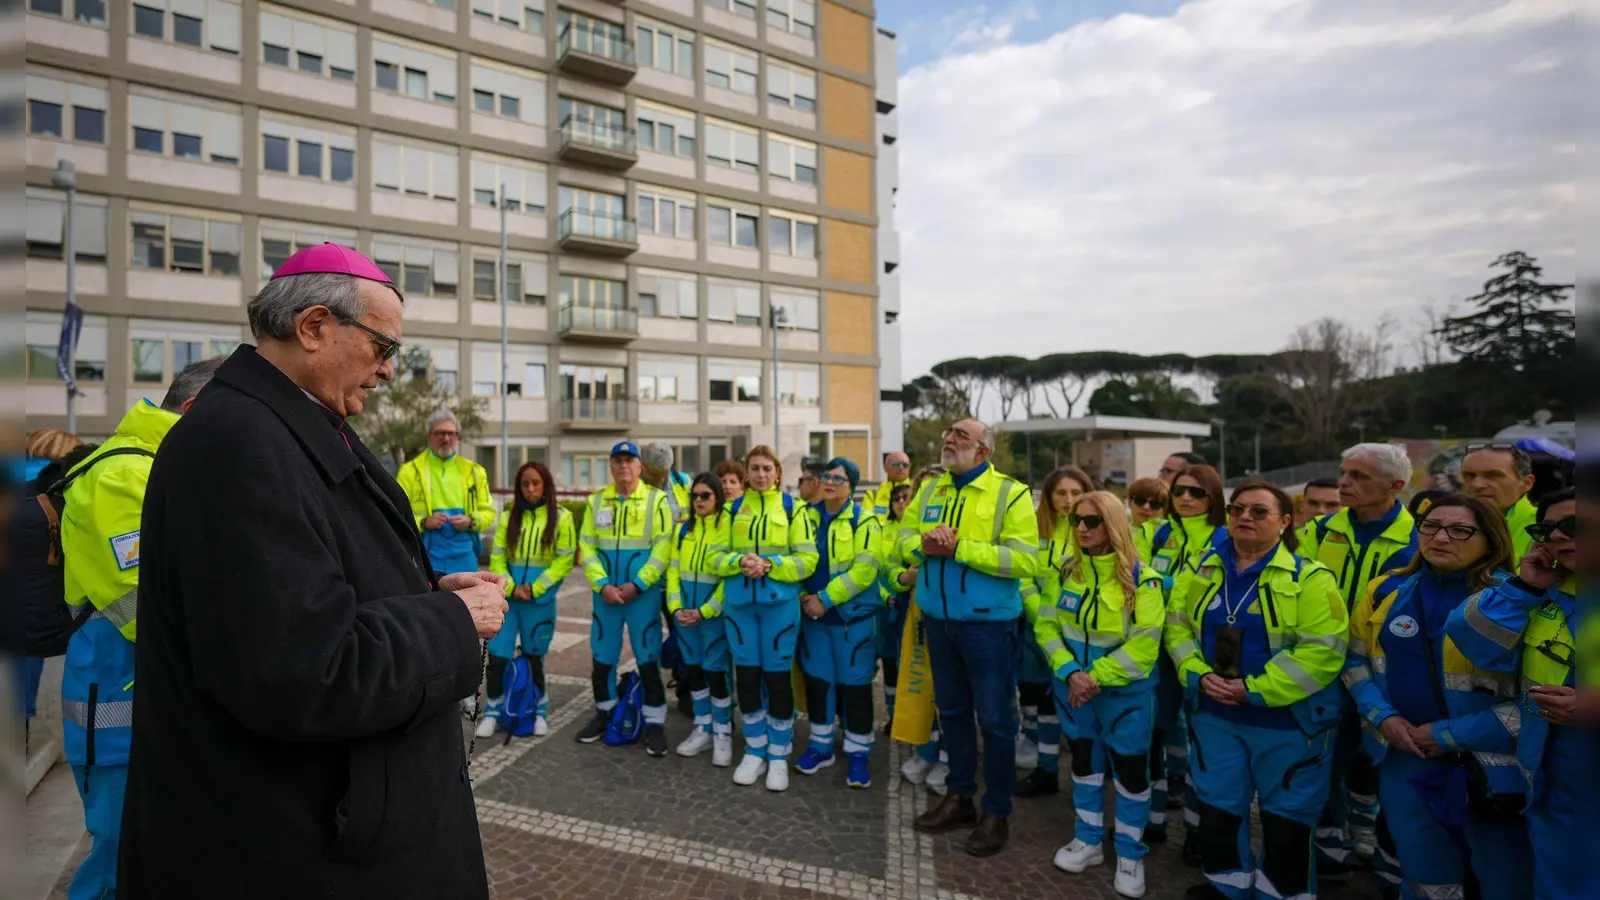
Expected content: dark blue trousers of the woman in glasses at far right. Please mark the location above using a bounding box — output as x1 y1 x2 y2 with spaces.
1378 749 1529 900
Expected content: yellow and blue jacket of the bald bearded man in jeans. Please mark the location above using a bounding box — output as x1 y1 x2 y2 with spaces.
899 463 1038 621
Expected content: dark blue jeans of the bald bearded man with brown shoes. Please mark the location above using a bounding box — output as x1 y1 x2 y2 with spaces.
923 617 1018 815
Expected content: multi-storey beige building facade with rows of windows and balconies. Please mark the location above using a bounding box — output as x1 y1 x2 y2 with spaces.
26 0 899 488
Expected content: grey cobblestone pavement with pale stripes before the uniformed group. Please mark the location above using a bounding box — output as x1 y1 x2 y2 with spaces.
474 573 1378 900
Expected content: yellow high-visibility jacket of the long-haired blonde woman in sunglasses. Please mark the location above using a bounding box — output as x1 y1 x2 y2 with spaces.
1034 552 1166 693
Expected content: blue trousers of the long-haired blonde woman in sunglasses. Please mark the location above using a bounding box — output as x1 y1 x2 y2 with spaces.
1054 679 1155 860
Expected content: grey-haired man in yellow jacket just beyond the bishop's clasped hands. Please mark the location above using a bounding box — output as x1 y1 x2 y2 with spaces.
395 410 494 575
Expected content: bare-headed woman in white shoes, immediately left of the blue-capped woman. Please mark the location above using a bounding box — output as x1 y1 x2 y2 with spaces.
715 445 818 791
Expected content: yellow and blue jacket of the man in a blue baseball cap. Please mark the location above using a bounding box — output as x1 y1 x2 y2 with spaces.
578 482 675 593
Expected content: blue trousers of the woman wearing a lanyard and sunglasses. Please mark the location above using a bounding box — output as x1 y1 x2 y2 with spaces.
1189 709 1333 900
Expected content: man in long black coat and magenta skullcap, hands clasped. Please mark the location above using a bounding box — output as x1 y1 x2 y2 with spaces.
118 243 506 900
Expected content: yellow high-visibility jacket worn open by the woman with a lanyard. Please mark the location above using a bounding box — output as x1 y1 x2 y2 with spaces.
1165 544 1350 727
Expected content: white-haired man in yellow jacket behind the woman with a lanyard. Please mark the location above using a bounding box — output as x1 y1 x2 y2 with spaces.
1301 444 1416 886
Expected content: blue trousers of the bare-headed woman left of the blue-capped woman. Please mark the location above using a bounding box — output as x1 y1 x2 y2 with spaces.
722 602 800 759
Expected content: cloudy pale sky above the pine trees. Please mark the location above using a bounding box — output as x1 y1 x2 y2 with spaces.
878 0 1578 378
